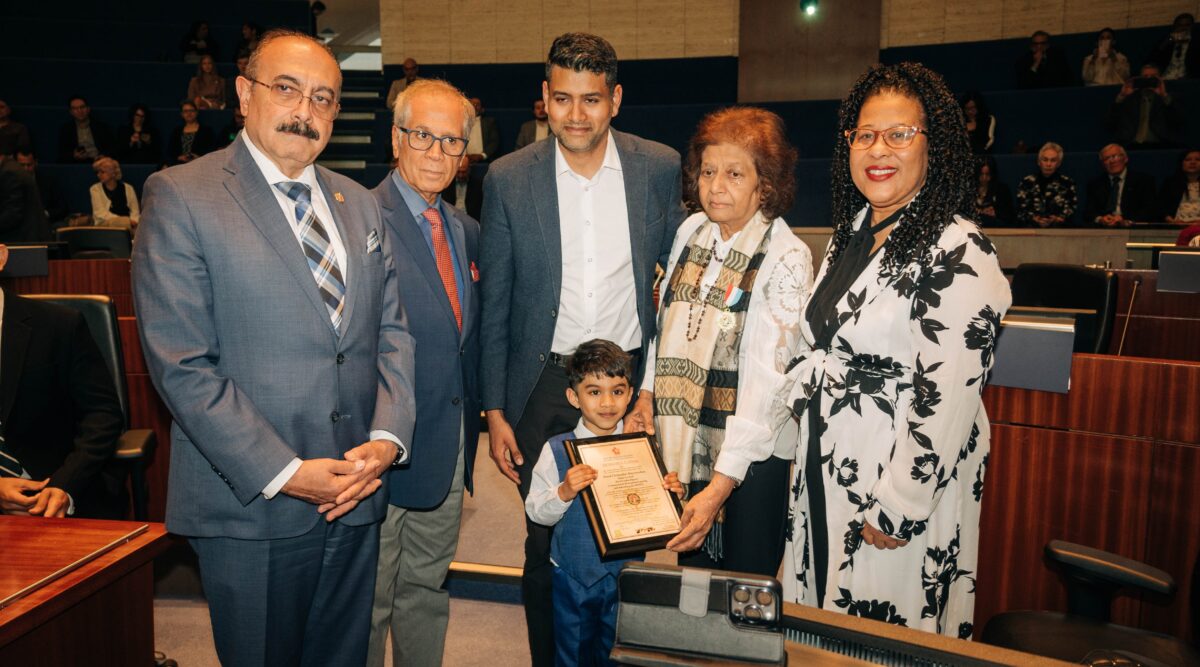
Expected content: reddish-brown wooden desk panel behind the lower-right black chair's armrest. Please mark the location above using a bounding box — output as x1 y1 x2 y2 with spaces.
976 425 1152 629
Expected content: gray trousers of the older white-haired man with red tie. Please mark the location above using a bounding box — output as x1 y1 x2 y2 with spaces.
367 435 463 667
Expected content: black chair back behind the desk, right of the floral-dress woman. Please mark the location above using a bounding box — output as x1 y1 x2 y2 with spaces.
1013 264 1117 354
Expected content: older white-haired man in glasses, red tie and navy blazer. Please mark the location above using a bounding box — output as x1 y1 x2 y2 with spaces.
367 79 480 666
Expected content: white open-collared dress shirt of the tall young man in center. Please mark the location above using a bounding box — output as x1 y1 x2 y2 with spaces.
550 132 642 355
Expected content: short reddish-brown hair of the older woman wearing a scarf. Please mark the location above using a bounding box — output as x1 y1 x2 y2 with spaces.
683 107 797 221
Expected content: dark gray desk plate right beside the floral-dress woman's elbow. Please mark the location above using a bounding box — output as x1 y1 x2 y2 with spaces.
988 308 1075 393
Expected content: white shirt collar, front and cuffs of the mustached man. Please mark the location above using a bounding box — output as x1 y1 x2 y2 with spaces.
241 132 408 500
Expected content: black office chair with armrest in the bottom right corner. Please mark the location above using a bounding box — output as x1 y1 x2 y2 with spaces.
980 540 1200 666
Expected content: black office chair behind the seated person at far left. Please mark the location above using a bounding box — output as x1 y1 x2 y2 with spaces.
26 294 157 521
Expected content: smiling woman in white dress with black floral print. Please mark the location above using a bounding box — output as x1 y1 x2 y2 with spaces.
784 64 1010 637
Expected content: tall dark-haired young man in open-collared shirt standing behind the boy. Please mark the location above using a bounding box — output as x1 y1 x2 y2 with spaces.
480 32 685 667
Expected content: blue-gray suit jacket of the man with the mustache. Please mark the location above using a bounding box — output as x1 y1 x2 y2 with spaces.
133 142 414 539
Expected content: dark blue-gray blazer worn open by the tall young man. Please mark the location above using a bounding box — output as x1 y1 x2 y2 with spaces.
480 130 686 423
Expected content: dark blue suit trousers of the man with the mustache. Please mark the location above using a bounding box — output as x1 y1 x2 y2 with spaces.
188 519 379 667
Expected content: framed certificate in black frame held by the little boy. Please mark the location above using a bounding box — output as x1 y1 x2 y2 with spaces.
564 433 683 558
